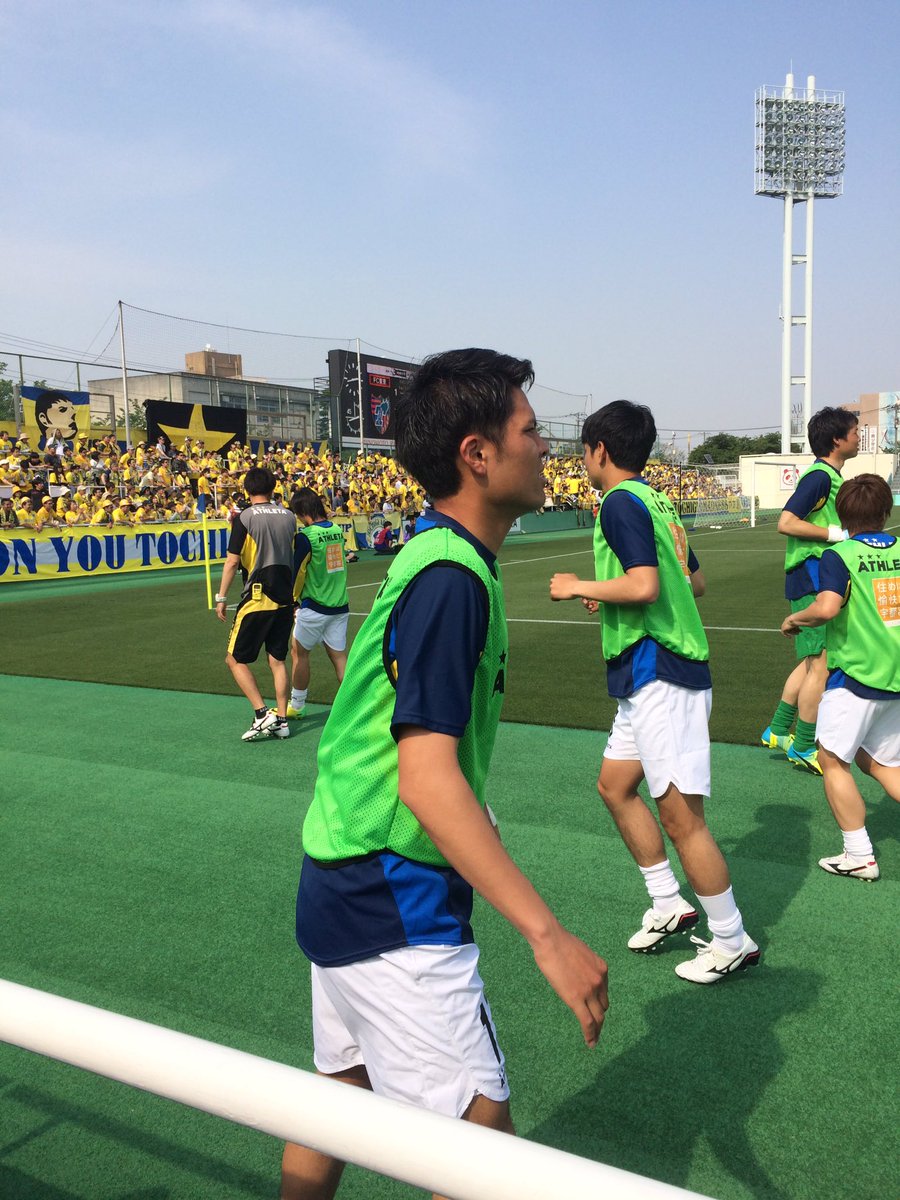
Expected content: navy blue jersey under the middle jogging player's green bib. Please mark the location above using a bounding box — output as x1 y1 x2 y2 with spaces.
600 479 713 698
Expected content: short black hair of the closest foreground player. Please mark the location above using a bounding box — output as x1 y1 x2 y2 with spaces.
391 349 534 499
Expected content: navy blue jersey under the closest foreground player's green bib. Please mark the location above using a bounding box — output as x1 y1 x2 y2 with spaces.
296 511 497 966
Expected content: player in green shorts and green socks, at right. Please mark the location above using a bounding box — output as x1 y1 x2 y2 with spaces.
760 408 859 775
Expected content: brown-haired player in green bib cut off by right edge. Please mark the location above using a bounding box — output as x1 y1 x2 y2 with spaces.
781 475 900 881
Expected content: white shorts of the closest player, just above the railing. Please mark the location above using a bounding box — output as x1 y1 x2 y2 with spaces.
312 946 509 1117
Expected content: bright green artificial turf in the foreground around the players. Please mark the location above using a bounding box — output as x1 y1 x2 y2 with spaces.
0 681 900 1200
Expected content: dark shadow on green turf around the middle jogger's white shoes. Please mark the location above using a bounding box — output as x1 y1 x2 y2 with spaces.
522 804 823 1200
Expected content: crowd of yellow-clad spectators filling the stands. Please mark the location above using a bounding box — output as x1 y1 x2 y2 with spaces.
0 430 733 532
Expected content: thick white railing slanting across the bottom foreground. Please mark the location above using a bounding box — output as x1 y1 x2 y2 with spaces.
0 980 696 1200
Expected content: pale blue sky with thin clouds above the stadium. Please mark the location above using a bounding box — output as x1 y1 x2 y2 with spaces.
0 0 900 444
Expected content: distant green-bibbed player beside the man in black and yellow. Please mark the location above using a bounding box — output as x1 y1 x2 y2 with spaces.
287 487 350 718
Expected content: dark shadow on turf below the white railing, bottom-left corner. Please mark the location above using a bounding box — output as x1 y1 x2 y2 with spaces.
0 1084 275 1200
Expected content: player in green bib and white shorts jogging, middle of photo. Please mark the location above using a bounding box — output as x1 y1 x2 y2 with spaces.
550 400 760 984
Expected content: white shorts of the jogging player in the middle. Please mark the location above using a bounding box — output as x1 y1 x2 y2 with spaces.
604 679 713 799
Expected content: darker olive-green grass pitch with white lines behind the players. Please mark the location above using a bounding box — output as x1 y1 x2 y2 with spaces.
0 527 816 743
